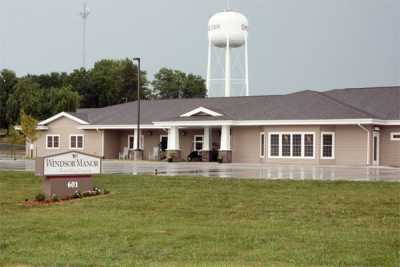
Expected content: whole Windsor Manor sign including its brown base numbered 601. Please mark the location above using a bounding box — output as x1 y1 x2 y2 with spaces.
35 151 101 198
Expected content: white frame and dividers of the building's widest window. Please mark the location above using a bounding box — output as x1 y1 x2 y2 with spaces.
266 132 316 160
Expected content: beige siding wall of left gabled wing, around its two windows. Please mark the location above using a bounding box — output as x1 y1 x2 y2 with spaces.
34 118 102 157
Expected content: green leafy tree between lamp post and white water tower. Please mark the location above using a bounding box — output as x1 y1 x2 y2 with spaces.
152 68 206 99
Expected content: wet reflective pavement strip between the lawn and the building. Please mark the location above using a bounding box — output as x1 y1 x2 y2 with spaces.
0 160 400 182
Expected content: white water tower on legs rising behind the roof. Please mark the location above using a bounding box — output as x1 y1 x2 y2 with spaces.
207 11 249 97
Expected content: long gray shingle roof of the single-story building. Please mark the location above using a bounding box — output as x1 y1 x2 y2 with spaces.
73 86 400 125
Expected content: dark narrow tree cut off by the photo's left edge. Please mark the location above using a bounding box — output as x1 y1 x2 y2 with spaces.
0 69 18 133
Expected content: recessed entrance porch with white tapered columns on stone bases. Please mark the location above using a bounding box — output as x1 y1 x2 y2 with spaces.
103 126 232 163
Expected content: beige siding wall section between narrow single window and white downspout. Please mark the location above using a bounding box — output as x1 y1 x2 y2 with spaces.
336 125 372 165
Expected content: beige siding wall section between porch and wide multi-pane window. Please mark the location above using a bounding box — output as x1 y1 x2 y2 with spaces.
231 127 263 163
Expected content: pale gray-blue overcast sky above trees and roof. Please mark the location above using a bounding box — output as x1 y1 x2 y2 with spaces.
0 0 400 95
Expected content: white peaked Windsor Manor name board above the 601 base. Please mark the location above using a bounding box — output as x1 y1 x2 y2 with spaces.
43 152 101 176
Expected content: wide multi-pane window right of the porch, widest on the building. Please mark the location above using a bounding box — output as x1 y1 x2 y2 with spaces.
269 133 315 158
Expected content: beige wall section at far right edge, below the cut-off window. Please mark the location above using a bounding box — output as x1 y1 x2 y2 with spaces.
380 126 400 167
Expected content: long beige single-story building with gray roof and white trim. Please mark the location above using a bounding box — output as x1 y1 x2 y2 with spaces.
27 87 400 166
